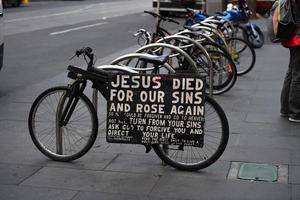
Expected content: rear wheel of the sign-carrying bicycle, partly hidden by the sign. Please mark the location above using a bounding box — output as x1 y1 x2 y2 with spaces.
153 96 229 171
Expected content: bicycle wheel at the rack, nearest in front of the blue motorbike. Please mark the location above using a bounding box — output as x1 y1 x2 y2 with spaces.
226 38 256 76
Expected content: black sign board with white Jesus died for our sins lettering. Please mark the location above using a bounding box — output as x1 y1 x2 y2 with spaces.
106 74 205 147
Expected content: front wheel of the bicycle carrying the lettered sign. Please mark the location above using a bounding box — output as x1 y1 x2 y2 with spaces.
28 87 98 161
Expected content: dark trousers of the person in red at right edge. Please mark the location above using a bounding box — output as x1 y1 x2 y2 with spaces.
280 46 300 119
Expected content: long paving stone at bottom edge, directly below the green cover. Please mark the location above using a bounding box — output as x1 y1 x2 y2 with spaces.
150 176 291 200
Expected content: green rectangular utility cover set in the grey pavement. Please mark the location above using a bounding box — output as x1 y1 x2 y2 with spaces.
238 163 278 182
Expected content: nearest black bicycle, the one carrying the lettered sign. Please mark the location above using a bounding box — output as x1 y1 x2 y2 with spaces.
28 47 229 170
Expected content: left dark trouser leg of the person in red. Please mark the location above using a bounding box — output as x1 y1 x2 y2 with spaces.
280 49 293 117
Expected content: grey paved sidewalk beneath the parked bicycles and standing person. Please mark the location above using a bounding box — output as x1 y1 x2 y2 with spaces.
0 41 300 200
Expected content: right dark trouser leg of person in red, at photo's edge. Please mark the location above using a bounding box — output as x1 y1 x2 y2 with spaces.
289 46 300 120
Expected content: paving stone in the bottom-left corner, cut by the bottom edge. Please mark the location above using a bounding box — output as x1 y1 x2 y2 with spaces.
0 185 77 200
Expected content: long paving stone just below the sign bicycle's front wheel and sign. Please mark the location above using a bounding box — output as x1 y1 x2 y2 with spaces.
21 167 159 195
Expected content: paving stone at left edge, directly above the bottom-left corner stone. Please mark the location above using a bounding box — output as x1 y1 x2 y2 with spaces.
0 163 40 185
